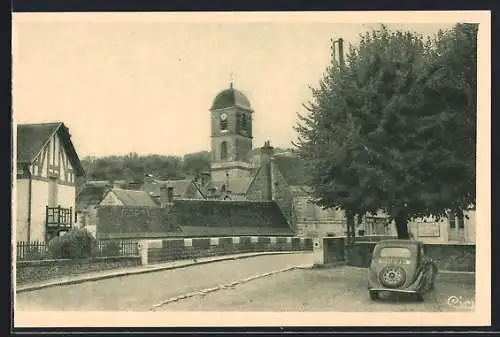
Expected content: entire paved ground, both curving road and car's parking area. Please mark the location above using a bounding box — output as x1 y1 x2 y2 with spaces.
16 253 475 312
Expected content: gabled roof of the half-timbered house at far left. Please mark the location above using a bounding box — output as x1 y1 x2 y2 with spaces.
17 122 85 176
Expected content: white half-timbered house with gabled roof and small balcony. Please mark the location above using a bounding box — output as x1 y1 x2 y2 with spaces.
15 122 84 242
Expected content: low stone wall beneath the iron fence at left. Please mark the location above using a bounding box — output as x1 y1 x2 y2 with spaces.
16 256 141 284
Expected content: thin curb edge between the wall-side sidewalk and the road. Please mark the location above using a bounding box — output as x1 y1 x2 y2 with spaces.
16 251 306 294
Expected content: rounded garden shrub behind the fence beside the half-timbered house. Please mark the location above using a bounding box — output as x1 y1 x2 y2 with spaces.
48 228 96 259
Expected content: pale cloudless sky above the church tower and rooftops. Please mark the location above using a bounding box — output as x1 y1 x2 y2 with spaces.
13 14 458 157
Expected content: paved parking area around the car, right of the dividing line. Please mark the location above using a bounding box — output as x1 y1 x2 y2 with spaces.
156 267 475 312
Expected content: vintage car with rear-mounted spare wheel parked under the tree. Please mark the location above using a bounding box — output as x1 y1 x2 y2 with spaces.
368 240 438 301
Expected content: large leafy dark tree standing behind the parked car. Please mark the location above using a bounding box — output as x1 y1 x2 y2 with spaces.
296 25 477 238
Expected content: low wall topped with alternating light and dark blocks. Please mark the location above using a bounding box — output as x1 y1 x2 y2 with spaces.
139 236 313 264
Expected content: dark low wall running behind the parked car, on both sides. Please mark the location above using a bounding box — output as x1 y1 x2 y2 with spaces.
323 238 476 272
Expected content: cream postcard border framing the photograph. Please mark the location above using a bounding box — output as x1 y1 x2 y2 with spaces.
12 11 491 327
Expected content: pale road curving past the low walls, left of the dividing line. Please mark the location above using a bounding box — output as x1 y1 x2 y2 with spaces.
16 253 315 311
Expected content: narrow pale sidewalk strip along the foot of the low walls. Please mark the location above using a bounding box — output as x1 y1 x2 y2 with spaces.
16 251 312 293
